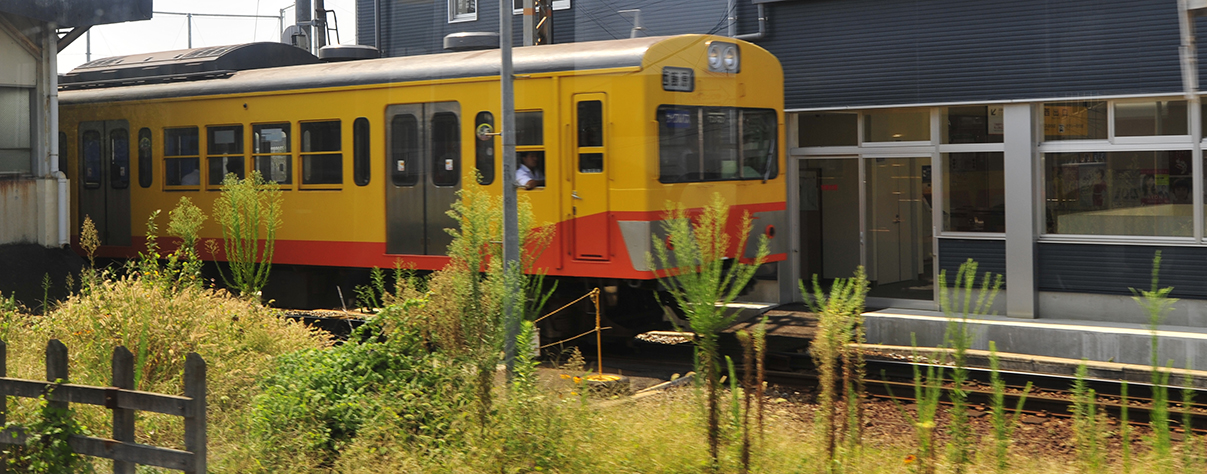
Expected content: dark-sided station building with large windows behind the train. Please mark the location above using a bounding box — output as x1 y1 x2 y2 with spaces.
357 0 1207 367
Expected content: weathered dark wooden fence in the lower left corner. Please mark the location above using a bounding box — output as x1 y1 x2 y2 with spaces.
0 339 205 474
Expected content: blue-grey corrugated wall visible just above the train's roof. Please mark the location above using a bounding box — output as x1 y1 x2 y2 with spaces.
356 0 738 57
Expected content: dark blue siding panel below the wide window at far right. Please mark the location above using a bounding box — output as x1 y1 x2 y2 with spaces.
1038 244 1207 299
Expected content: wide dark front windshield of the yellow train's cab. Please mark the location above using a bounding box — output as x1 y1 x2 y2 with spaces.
657 105 779 183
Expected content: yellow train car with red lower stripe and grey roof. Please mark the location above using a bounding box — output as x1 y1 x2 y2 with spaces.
59 35 787 328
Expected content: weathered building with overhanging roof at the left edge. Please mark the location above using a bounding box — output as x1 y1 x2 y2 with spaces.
0 0 152 304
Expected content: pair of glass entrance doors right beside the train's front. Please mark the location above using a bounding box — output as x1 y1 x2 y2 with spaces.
799 157 934 304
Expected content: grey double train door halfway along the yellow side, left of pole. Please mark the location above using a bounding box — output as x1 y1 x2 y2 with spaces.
385 103 461 254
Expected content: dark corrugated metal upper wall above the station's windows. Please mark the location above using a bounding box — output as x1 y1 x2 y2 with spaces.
760 0 1205 109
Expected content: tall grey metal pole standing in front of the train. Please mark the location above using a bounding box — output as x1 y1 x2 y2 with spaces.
498 0 519 378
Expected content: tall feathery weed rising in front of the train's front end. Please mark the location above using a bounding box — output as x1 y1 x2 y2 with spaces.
651 194 768 466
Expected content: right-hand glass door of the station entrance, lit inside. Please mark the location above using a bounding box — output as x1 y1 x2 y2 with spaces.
864 158 934 299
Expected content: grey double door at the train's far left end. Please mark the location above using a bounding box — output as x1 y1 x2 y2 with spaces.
78 121 130 246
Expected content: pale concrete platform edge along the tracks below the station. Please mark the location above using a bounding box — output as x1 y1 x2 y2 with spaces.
863 309 1207 369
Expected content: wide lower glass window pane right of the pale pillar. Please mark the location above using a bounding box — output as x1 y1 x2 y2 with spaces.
1044 151 1194 236
